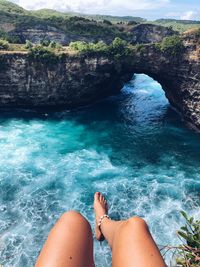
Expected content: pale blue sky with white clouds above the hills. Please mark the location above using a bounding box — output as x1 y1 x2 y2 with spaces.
11 0 200 20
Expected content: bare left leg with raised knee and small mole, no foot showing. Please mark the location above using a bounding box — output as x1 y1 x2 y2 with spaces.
35 211 94 267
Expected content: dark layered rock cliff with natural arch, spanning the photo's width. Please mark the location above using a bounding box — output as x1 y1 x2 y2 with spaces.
0 36 200 130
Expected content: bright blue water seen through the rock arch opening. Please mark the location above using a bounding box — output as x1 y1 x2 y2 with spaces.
115 73 170 126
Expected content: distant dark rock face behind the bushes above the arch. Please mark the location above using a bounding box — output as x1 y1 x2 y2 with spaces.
130 24 178 44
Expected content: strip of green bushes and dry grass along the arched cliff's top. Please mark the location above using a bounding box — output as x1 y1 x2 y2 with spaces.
0 34 186 58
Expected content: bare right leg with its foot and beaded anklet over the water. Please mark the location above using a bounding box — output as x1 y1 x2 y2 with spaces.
94 193 166 267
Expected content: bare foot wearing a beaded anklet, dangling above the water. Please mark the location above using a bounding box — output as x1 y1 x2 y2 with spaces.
94 192 108 241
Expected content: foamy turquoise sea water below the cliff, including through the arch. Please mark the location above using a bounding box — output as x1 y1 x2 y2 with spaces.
0 75 200 267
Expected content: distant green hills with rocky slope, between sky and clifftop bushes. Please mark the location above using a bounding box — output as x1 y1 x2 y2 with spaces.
0 0 200 44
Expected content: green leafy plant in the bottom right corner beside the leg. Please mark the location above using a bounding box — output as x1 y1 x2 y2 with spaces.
163 211 200 267
